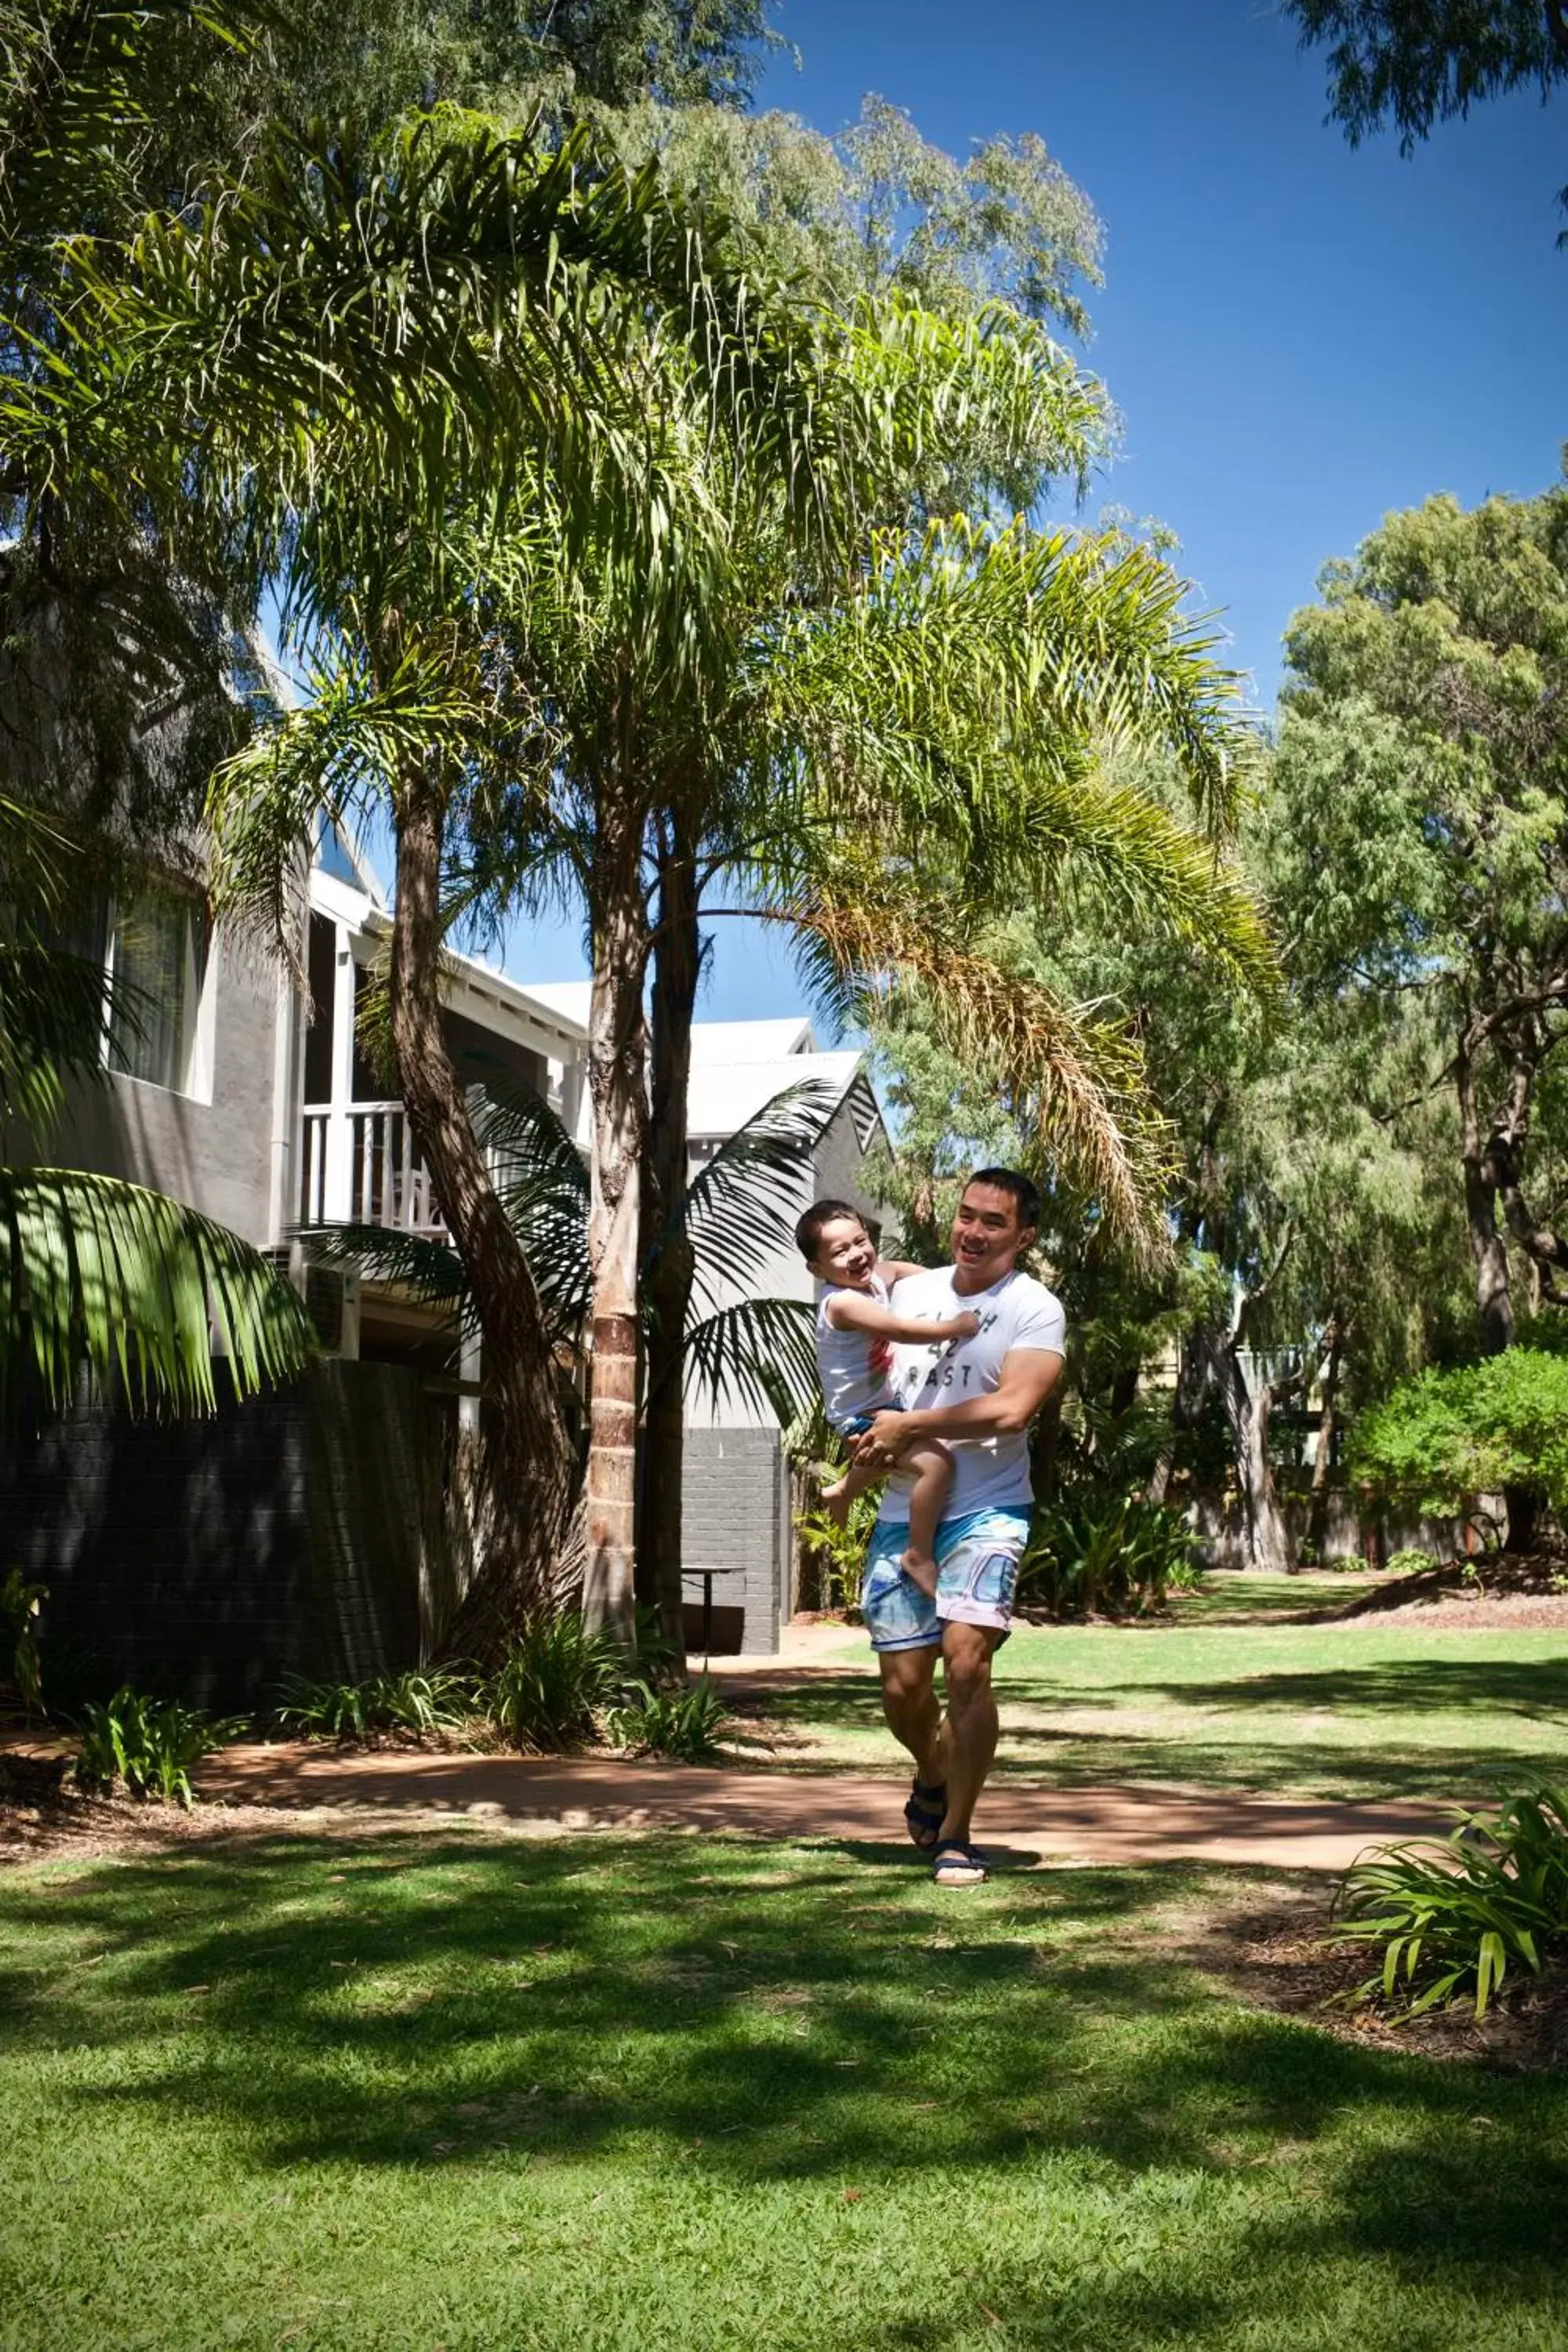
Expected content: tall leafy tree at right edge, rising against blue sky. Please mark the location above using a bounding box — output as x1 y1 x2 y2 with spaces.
1274 489 1568 1352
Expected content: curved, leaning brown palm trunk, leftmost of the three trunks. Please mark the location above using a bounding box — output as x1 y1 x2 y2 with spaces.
390 779 574 1663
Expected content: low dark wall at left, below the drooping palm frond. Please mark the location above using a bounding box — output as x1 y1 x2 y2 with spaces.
0 1362 440 1710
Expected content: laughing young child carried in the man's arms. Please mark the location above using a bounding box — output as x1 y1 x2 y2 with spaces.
794 1200 980 1592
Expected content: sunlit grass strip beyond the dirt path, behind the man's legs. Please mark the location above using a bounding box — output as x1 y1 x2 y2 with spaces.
746 1578 1568 1799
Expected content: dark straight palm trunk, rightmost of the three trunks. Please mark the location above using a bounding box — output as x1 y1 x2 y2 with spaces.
637 823 703 1665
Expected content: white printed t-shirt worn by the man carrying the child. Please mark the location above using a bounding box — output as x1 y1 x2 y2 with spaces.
877 1265 1067 1522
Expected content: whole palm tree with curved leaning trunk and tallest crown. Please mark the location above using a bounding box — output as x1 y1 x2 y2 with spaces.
108 101 869 1653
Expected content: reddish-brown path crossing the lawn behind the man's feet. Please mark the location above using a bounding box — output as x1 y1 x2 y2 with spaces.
200 1745 1446 1870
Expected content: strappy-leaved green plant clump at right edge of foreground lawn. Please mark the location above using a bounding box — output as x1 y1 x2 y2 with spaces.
1333 1788 1568 2018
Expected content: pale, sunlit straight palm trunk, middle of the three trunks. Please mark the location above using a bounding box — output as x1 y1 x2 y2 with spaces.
583 793 649 1642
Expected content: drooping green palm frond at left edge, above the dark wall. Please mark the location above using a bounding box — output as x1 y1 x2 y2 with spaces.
0 1169 320 1414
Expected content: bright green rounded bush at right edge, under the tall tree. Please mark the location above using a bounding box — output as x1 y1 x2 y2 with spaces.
1349 1348 1568 1517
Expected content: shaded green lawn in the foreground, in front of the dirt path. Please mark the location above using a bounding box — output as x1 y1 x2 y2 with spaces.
0 1835 1568 2352
